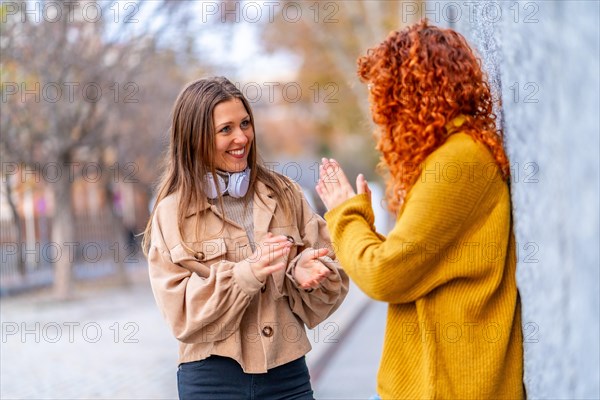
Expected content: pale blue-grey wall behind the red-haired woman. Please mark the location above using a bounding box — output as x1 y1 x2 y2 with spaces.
424 1 600 399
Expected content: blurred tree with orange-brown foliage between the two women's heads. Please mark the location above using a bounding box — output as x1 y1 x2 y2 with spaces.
259 0 422 178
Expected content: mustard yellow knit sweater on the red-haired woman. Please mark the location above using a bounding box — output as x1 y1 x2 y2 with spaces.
325 133 524 400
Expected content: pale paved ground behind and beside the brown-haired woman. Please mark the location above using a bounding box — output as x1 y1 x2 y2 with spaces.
0 270 379 400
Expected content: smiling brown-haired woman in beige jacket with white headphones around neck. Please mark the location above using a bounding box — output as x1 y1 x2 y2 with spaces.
143 78 348 400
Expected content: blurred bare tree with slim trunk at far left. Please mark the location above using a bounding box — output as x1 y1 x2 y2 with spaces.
0 1 202 298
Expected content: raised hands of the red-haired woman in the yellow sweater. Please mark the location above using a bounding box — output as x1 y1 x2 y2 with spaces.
316 158 371 210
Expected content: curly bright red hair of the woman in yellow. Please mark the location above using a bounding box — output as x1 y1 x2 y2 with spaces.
358 20 509 212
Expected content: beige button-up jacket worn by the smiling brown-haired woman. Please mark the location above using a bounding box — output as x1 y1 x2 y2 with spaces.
148 182 348 373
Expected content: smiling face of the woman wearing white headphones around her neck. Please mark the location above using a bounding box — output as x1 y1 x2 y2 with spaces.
213 99 254 172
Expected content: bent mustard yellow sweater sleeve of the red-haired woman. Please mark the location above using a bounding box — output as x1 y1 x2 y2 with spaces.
325 135 499 303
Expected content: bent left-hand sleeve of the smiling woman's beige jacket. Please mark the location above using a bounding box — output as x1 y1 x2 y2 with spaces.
148 214 262 343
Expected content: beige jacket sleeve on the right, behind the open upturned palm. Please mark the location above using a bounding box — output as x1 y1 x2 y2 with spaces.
284 187 349 329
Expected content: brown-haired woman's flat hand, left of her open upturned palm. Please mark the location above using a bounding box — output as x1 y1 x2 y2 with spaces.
244 232 292 282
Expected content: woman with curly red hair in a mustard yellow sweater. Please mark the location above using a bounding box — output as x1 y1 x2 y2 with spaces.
317 21 525 399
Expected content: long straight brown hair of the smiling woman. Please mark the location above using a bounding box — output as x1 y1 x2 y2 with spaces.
142 77 294 255
